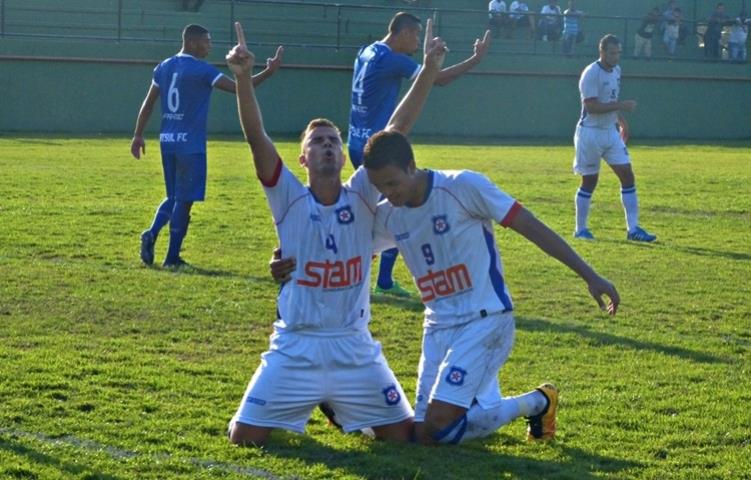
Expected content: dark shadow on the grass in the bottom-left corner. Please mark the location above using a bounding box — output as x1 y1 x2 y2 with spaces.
0 438 121 480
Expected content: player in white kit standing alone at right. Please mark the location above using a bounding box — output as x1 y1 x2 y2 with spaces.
574 34 657 242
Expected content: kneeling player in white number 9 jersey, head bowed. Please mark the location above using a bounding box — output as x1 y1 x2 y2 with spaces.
364 129 619 444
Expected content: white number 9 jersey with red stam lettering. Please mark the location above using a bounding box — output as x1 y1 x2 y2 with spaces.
374 170 521 327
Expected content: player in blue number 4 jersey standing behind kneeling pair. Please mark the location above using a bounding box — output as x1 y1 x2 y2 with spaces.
347 12 490 297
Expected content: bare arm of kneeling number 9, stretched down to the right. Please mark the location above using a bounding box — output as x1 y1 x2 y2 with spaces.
509 208 621 315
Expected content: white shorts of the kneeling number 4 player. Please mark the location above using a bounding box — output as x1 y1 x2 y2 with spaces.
232 331 413 433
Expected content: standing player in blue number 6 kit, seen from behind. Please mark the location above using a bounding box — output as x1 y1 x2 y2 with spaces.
130 25 283 267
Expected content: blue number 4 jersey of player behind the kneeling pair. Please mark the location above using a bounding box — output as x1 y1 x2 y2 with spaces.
347 42 420 156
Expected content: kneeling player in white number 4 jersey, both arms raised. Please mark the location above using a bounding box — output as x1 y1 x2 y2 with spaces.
222 24 445 445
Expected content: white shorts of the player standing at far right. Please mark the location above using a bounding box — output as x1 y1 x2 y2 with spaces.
574 125 631 175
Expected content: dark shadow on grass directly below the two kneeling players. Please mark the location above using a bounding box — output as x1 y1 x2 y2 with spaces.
258 432 640 480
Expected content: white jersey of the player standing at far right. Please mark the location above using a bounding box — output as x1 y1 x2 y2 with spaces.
579 61 621 128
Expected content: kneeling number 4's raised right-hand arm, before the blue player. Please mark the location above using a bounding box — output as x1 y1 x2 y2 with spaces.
385 19 448 135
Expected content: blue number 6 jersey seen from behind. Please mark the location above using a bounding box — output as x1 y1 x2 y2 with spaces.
153 53 222 154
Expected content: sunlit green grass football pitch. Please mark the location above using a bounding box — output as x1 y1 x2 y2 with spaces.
0 136 751 480
